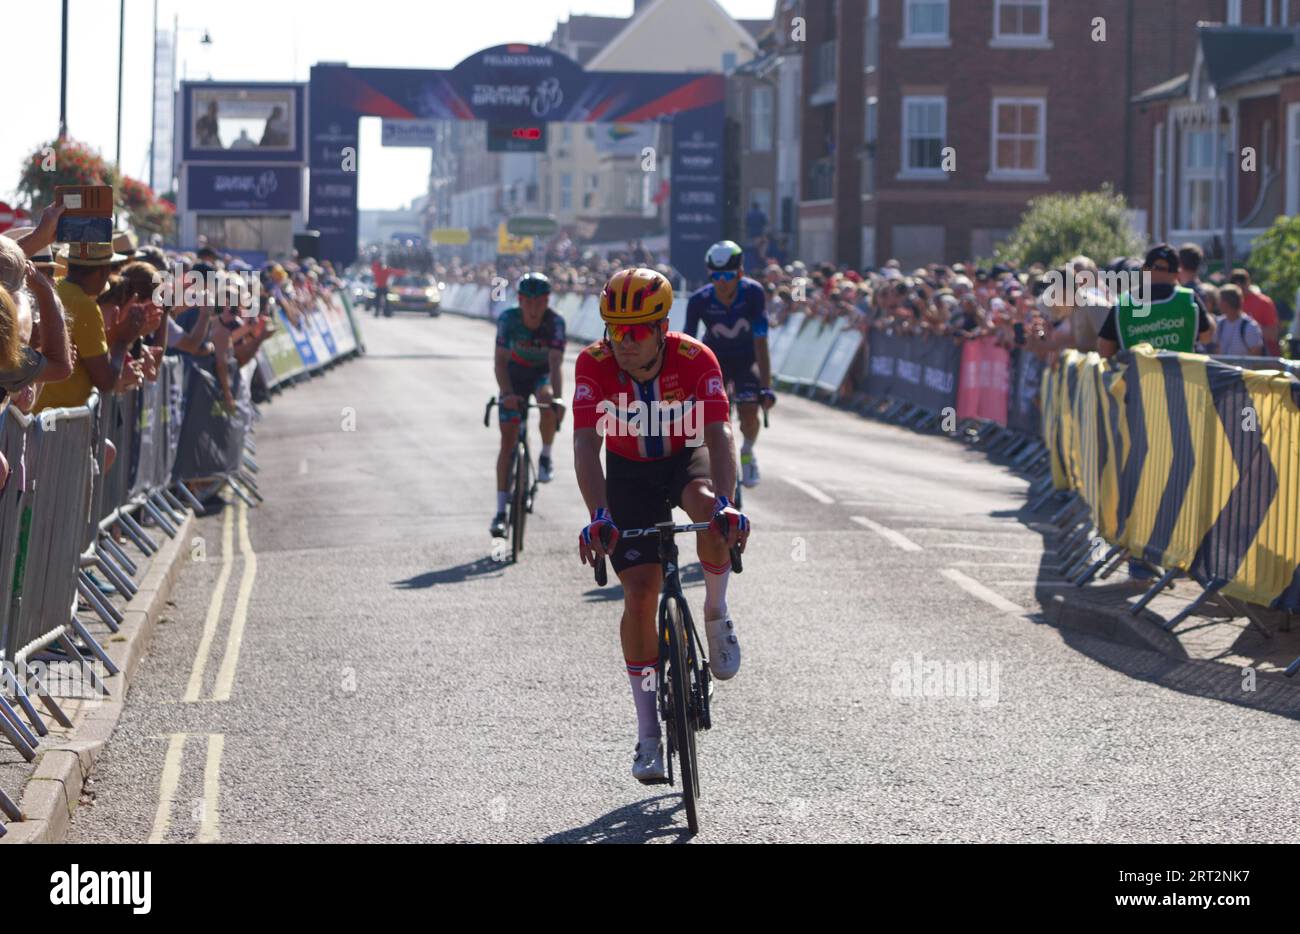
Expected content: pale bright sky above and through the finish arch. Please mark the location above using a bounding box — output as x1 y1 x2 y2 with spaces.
10 0 776 209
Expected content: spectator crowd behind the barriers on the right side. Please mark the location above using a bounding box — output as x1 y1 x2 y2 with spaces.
430 238 1290 377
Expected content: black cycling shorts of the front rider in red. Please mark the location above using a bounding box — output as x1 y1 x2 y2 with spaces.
605 445 710 572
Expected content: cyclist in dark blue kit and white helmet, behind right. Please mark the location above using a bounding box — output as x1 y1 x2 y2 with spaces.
683 239 776 487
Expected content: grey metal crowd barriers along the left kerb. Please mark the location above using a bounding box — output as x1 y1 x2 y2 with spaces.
0 338 279 835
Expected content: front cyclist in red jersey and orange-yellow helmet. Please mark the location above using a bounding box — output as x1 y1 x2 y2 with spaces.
572 269 749 783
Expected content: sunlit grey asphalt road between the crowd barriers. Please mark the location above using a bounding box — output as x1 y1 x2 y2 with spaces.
70 315 1300 843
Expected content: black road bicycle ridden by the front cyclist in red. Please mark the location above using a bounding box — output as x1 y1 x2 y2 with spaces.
595 520 744 834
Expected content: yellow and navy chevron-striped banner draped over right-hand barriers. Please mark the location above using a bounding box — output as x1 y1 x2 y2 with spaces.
1043 346 1300 611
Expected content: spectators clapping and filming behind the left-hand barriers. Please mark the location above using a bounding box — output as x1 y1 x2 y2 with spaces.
0 206 353 504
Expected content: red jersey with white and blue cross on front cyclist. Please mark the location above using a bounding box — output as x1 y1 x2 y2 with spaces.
572 332 728 460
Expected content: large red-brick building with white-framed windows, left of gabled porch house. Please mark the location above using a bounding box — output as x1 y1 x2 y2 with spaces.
779 0 1258 265
